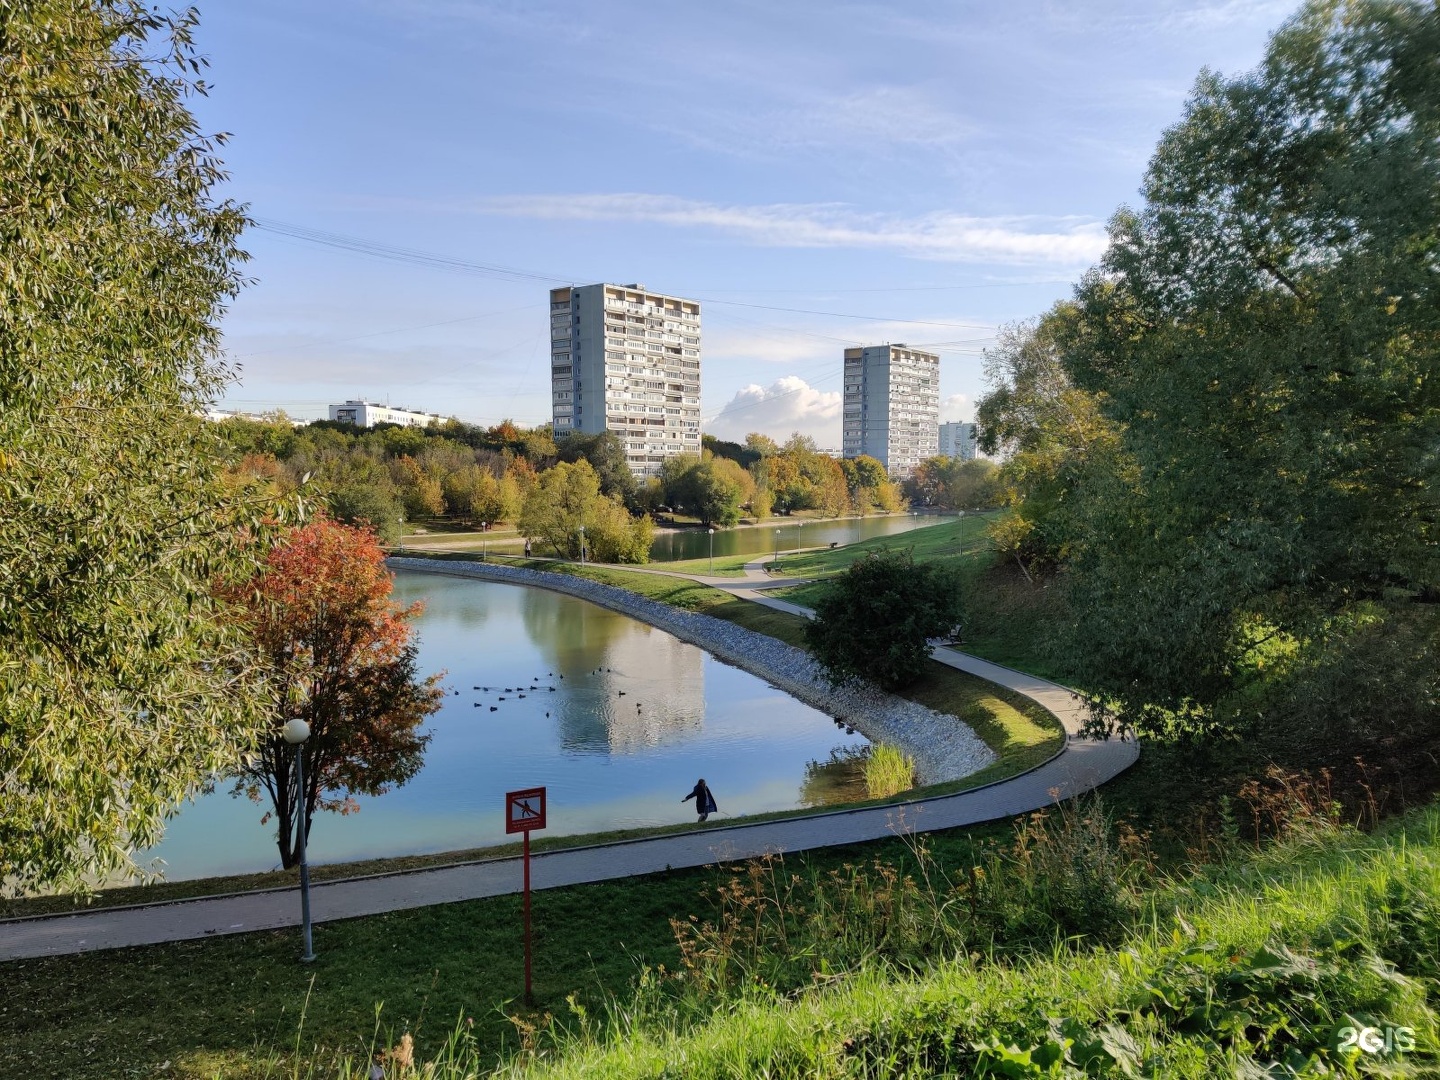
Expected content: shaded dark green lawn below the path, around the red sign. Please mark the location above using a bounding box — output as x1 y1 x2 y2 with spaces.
0 829 1025 1080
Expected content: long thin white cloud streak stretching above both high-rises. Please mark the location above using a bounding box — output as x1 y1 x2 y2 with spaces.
471 193 1106 268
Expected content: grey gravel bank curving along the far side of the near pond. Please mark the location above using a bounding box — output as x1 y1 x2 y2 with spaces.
384 557 995 783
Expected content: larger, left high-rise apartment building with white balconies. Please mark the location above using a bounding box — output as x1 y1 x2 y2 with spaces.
550 284 700 477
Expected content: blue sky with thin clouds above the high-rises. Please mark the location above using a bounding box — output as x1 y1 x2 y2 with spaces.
193 0 1293 446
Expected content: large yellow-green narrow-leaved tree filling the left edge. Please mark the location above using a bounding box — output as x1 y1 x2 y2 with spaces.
0 0 283 888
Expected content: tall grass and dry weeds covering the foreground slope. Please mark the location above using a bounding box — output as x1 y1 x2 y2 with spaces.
306 783 1440 1080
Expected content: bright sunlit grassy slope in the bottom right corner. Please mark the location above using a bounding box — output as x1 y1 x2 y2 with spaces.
506 809 1440 1080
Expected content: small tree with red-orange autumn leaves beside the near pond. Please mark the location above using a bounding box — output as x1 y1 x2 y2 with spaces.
225 517 444 868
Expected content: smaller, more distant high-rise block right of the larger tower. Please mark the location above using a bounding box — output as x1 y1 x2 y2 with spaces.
844 346 940 477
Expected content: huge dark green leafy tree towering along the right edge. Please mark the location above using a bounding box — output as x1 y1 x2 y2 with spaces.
1064 0 1440 730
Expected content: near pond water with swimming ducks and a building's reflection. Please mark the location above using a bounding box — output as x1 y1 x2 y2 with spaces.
141 572 865 880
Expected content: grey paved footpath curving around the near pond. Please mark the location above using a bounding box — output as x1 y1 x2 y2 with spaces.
0 559 1139 960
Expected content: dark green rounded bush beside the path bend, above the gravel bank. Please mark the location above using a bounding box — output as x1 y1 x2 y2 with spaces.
805 550 960 690
